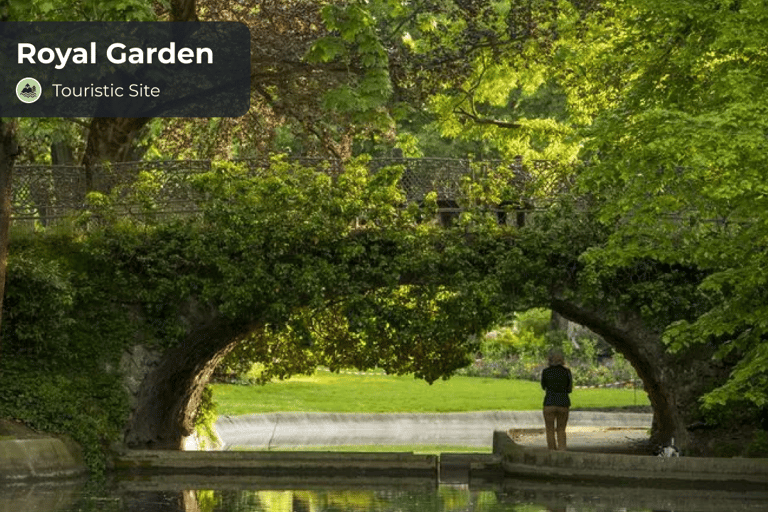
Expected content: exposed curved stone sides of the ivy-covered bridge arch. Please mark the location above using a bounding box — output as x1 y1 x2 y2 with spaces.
125 298 701 450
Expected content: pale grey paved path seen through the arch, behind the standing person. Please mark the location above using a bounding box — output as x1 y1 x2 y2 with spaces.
216 411 653 450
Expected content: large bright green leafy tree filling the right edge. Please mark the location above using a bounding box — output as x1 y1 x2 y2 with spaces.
568 1 768 420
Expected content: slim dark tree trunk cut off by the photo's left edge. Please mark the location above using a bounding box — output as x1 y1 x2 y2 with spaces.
0 119 19 351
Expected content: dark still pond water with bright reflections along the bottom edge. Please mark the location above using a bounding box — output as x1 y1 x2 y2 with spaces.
0 475 768 512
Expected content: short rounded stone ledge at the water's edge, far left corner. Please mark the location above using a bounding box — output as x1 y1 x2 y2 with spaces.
0 437 87 482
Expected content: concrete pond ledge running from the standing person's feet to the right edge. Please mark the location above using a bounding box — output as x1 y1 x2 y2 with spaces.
493 431 768 488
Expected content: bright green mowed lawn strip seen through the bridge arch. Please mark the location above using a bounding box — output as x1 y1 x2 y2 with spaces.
212 371 649 416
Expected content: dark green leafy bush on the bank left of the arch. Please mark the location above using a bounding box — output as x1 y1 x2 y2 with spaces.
0 235 133 474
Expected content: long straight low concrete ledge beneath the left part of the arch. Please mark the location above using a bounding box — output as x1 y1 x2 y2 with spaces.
114 450 438 479
